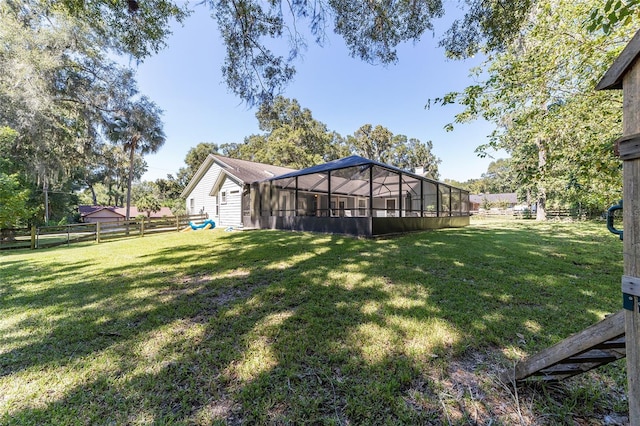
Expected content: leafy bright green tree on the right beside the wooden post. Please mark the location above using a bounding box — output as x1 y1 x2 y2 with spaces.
436 0 635 213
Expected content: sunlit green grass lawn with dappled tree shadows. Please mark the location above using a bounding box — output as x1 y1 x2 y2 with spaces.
0 221 626 425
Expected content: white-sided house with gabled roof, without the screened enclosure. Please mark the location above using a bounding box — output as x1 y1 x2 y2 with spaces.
181 154 295 226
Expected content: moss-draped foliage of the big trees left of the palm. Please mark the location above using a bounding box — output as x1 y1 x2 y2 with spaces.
0 1 160 220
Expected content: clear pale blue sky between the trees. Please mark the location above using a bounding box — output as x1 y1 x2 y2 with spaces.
131 6 505 181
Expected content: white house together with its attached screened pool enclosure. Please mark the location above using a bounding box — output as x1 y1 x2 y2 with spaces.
181 154 469 236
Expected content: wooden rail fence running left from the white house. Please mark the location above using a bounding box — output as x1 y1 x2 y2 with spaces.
0 215 207 250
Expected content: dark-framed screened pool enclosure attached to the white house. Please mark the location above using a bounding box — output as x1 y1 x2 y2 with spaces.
245 156 469 236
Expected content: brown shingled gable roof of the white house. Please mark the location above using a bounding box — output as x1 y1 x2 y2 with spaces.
181 154 295 197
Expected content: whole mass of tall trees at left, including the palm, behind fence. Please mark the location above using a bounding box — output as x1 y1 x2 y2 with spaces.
0 1 165 228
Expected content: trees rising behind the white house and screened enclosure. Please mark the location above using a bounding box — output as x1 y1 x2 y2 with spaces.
80 97 440 221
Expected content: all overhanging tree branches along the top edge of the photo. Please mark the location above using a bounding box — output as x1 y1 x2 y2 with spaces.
47 0 564 105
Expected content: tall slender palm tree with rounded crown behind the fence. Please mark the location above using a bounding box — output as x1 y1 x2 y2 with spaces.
108 96 166 220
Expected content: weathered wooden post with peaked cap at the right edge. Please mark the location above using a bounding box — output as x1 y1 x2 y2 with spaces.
596 31 640 426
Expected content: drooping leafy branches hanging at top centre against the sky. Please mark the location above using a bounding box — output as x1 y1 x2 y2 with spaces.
208 0 443 104
